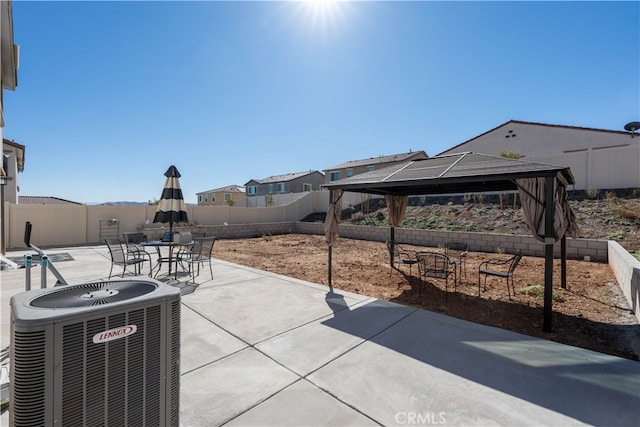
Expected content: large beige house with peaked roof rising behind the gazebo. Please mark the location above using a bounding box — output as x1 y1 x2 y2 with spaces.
438 120 640 190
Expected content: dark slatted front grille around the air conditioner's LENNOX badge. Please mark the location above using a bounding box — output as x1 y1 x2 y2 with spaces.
62 306 162 425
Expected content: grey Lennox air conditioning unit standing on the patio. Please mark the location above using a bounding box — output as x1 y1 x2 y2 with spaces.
9 279 180 427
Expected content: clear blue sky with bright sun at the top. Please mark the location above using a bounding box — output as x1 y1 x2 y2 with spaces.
4 0 640 203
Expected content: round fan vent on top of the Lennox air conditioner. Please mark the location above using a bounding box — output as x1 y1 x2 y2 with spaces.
29 280 158 309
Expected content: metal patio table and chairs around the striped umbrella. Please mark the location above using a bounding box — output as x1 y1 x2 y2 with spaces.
105 232 216 282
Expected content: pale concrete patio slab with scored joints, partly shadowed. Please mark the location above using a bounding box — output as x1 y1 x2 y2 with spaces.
0 246 640 426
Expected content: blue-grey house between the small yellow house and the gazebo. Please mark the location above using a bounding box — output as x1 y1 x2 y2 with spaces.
244 171 324 197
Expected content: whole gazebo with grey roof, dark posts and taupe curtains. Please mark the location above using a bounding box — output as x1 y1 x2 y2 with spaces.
323 152 577 332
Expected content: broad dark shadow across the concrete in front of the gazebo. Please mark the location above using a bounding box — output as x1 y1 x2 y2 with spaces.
322 295 640 426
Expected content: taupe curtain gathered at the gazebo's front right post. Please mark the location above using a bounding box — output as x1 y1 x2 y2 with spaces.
516 178 578 242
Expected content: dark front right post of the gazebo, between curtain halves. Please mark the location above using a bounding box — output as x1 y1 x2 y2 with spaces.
542 176 555 332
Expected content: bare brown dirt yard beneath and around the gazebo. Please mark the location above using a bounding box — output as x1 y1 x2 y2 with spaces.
214 234 640 360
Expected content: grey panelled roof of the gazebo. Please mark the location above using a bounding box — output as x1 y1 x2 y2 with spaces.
322 152 575 195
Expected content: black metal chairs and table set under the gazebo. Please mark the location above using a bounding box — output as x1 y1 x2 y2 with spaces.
387 241 522 300
